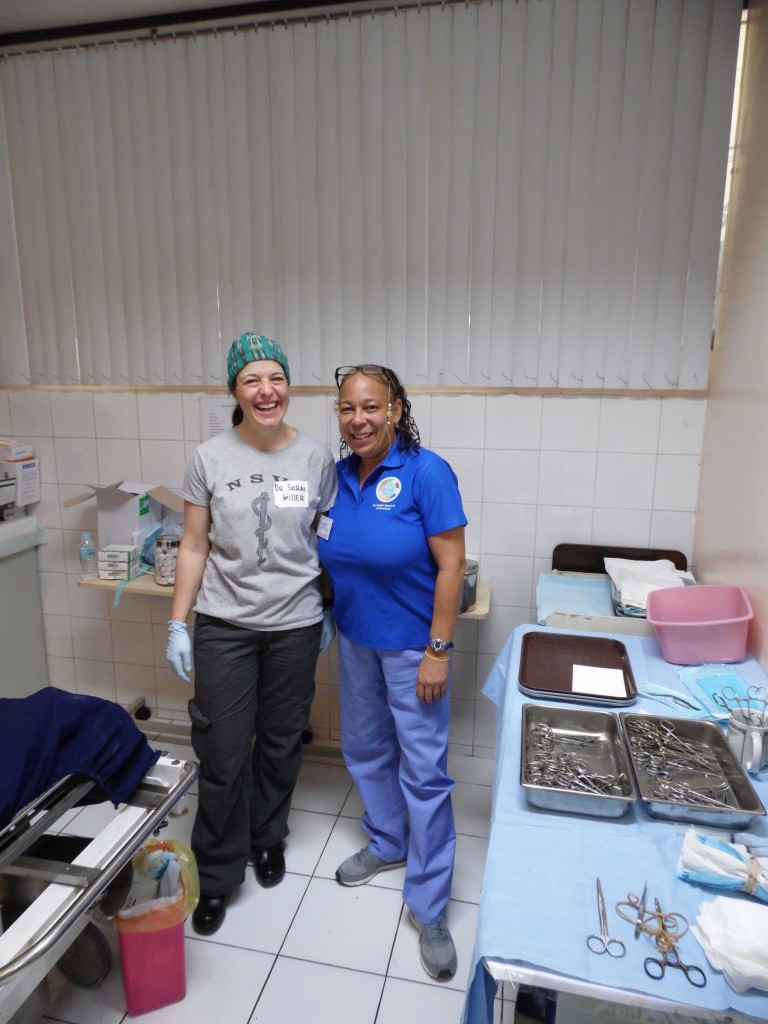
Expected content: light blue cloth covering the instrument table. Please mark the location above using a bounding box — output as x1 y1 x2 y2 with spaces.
463 626 768 1024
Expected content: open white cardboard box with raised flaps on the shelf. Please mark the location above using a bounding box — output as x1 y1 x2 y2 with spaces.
63 480 184 548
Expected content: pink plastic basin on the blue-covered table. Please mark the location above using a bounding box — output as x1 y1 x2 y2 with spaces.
646 584 753 665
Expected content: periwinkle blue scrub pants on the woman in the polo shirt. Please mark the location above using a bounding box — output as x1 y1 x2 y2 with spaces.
339 634 456 925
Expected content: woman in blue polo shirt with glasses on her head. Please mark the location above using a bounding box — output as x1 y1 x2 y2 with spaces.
317 364 467 978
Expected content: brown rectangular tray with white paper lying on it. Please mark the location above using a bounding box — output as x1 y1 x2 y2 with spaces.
517 630 637 708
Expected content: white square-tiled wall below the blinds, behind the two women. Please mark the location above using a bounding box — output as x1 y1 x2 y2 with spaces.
13 389 707 756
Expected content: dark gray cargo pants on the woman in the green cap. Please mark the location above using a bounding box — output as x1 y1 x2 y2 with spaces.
189 614 322 896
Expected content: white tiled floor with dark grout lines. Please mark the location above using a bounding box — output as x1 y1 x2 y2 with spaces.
30 746 514 1024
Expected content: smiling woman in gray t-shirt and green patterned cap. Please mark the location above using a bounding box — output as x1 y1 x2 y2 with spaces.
167 333 336 935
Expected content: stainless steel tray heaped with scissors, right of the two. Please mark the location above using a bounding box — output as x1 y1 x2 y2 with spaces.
620 712 765 829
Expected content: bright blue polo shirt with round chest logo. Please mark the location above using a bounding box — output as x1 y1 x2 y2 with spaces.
317 440 467 650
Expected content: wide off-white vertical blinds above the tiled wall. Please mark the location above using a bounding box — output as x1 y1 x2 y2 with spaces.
0 0 741 389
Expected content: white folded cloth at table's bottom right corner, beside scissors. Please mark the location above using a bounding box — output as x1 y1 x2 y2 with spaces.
690 896 768 992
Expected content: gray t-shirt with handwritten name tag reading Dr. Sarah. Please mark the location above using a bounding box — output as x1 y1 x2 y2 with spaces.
181 427 336 630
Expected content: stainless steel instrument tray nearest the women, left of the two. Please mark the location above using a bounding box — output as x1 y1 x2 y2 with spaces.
520 703 638 818
